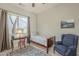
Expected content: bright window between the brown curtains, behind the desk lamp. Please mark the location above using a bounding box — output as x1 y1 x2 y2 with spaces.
8 13 28 37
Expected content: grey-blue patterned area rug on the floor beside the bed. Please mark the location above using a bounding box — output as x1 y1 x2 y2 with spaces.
7 46 49 56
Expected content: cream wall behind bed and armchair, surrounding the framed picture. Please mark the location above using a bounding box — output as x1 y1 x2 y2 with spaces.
37 4 79 40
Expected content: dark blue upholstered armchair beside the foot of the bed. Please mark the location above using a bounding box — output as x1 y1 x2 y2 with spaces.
54 34 78 56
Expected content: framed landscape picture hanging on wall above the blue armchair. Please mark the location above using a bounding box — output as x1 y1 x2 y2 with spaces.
61 19 75 28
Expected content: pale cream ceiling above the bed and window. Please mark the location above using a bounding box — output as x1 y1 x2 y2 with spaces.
11 3 58 14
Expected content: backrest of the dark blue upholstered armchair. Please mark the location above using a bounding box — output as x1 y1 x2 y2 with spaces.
62 34 78 47
